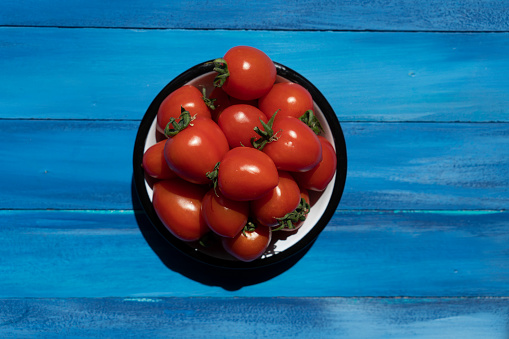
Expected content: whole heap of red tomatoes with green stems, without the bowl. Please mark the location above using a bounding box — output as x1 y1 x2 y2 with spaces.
143 46 337 261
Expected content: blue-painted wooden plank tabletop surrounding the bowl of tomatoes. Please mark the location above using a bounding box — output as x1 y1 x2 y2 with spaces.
0 0 509 338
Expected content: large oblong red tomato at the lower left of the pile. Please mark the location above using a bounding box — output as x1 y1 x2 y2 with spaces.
152 178 209 241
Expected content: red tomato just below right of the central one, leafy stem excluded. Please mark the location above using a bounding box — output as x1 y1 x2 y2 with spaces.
251 171 301 226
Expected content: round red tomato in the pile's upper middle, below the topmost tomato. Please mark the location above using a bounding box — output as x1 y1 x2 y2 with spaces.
217 104 267 148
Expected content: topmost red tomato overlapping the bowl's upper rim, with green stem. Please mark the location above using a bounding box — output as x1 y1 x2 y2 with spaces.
214 46 276 100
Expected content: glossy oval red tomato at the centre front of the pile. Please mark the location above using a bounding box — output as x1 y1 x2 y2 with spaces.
217 147 279 201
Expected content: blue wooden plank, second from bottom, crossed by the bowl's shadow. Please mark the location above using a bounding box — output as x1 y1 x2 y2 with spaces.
0 210 509 298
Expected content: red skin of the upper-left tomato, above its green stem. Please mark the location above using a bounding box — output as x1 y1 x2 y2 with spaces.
157 85 211 132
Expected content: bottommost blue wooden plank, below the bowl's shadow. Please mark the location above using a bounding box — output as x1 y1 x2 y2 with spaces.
0 298 509 339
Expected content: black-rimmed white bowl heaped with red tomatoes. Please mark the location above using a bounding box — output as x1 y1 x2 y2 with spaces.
133 46 347 268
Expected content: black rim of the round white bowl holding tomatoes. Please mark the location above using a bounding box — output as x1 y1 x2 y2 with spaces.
133 60 347 269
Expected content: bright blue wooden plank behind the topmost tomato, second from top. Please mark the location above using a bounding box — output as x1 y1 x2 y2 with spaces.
0 27 509 122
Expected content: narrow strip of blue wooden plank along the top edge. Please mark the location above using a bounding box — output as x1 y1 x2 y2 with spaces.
0 0 509 31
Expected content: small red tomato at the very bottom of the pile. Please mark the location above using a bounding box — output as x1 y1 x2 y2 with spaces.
222 225 272 262
